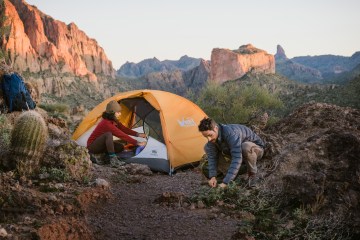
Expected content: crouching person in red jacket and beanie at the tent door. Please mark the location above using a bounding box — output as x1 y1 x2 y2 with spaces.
87 100 146 167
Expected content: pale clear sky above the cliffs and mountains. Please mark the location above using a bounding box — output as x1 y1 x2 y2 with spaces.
25 0 360 69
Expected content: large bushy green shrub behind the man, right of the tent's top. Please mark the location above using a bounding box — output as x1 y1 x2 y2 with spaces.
194 83 283 123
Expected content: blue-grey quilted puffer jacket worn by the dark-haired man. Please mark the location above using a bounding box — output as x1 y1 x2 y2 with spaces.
205 124 265 184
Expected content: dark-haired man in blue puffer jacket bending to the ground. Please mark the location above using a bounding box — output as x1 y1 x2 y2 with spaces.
198 118 265 187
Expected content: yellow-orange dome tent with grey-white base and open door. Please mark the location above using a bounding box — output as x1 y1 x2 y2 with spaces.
72 90 207 173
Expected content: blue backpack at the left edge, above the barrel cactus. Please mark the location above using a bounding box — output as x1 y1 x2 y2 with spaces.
1 73 36 112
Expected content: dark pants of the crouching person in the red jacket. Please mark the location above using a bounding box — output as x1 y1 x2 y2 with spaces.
88 132 124 154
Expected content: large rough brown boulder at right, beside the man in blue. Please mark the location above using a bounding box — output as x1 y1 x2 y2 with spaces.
261 103 360 234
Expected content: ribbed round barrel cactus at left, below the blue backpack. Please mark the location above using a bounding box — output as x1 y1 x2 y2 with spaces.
10 111 48 176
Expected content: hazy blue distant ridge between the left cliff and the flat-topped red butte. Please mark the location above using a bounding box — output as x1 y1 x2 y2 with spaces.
117 55 201 78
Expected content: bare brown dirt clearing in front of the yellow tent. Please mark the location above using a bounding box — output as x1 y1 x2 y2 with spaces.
85 166 239 240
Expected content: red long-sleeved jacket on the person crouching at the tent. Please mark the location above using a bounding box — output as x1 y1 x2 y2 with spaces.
87 119 137 146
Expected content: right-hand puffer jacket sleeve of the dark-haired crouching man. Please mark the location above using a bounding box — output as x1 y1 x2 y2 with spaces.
223 134 242 184
